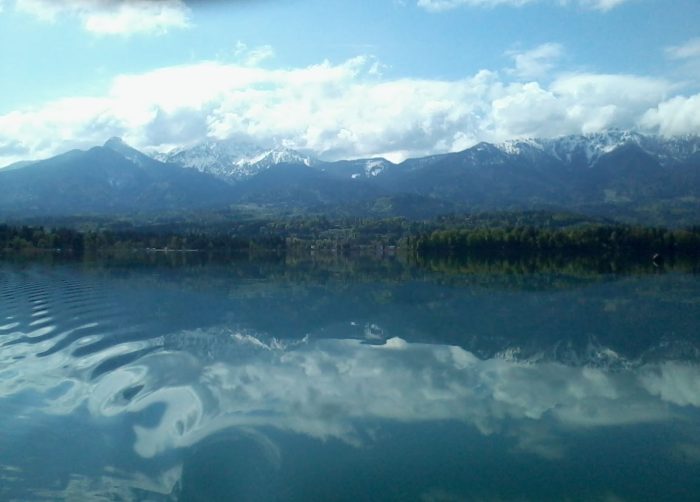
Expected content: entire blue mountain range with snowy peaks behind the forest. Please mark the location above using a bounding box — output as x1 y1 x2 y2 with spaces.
0 130 700 225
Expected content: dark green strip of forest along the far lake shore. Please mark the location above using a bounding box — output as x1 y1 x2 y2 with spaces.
0 212 700 259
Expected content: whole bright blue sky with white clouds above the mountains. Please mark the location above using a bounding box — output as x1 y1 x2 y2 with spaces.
0 0 700 165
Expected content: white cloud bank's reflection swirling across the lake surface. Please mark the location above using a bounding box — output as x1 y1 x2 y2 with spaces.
0 329 700 458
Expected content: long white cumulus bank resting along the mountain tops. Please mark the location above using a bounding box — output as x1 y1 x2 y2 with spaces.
0 53 698 165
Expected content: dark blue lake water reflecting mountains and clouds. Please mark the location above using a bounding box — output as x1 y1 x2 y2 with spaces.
0 256 700 501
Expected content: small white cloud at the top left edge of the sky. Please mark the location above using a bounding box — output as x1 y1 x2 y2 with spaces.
15 0 190 35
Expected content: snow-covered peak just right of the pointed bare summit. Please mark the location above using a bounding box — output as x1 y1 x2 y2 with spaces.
154 140 314 182
